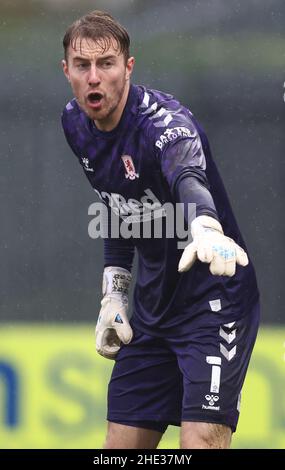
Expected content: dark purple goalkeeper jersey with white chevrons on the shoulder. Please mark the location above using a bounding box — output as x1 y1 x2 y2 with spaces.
62 84 258 336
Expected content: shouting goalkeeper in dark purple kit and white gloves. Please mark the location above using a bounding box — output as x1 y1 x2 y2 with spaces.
62 11 259 449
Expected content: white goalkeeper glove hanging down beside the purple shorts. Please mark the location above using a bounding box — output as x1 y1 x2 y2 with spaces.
95 266 133 359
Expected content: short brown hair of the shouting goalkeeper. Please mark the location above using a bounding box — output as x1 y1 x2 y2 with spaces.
63 10 130 63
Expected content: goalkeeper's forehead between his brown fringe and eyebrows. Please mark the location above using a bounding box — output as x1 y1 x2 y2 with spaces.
68 37 122 59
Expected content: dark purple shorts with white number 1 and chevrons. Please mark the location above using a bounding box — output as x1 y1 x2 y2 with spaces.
107 304 259 432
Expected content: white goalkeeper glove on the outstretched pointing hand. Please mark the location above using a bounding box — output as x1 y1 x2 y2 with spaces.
178 215 248 276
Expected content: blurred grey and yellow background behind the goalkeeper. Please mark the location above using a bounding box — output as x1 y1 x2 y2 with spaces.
0 0 285 448
